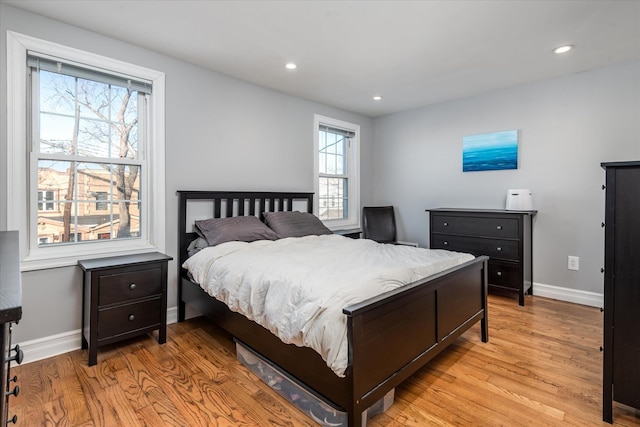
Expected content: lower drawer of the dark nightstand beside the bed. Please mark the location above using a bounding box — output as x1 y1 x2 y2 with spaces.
98 297 161 340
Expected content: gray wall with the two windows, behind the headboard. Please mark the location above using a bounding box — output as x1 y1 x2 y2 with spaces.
0 4 373 345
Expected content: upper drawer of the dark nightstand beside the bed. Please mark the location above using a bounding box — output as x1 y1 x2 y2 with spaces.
98 265 162 306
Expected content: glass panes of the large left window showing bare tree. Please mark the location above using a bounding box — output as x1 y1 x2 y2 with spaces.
35 70 141 245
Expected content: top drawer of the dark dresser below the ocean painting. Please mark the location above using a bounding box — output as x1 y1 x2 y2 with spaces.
431 214 519 239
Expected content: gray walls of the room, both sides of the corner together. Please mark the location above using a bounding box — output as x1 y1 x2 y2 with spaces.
0 4 640 350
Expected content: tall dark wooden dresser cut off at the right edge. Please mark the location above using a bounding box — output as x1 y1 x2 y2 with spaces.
602 161 640 422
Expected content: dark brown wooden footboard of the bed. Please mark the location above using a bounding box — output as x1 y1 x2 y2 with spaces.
343 257 489 427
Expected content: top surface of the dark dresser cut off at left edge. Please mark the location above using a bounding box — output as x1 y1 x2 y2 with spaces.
0 231 22 323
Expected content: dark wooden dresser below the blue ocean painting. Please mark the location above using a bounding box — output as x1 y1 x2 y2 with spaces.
427 208 537 305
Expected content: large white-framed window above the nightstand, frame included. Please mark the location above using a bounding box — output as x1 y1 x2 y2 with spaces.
7 32 164 270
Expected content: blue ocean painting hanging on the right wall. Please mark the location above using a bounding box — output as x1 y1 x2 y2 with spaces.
462 130 518 172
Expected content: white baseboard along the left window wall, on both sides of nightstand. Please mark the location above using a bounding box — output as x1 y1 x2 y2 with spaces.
18 307 178 364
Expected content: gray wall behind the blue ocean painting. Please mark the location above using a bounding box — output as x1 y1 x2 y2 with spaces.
373 62 640 293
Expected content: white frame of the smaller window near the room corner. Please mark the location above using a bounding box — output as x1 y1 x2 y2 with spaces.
313 114 360 231
